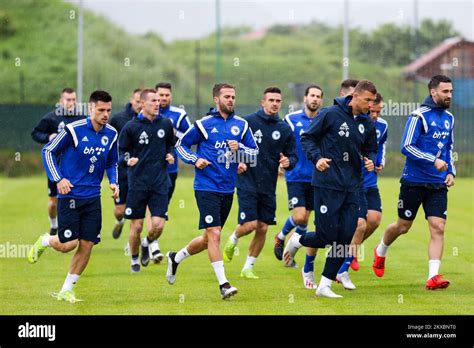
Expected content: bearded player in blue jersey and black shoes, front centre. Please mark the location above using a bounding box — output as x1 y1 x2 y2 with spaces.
166 83 258 299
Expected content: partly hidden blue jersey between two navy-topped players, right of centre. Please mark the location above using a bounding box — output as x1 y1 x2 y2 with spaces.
285 109 314 183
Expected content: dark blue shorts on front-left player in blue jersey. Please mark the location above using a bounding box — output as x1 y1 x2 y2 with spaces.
58 197 102 244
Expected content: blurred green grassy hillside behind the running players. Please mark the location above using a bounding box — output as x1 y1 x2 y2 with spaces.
0 0 460 112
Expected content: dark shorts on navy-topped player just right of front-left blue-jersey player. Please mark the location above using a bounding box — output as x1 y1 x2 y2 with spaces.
125 190 168 220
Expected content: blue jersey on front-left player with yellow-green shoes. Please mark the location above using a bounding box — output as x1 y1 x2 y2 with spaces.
42 118 118 198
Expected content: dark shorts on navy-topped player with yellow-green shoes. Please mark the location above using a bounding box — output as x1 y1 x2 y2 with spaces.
237 189 276 225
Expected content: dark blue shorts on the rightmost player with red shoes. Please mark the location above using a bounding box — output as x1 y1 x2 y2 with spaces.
398 184 448 221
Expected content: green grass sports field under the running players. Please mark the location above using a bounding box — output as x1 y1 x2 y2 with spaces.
0 176 474 315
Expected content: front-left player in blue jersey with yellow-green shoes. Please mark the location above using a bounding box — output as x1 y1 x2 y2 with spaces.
28 91 119 303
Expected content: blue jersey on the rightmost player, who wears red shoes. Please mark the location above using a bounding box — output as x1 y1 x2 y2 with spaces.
400 96 456 184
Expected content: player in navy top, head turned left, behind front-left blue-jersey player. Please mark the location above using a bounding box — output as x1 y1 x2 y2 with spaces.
119 89 175 273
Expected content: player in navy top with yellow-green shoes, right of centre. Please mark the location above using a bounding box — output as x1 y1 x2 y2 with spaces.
223 87 298 279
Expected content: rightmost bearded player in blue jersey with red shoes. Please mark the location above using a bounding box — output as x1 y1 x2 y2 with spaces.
372 75 456 290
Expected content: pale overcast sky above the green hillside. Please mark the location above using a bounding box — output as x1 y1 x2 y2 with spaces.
70 0 474 42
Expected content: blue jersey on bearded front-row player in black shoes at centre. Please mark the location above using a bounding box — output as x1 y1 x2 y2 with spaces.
176 111 258 193
